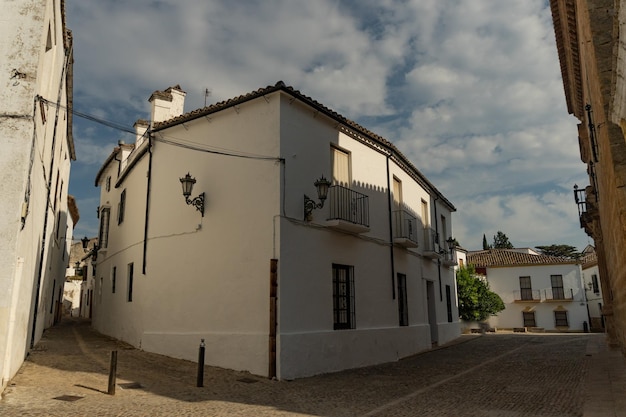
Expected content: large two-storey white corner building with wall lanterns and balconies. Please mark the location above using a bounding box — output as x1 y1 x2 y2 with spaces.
92 82 460 379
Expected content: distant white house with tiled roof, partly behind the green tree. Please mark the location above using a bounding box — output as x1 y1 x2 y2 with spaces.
467 248 589 331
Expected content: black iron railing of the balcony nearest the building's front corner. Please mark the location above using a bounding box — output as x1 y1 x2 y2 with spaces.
328 185 370 227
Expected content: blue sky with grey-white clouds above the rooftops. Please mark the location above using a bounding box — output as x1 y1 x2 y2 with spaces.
66 0 593 250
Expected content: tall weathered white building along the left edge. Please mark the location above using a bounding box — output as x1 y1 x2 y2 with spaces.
0 0 75 389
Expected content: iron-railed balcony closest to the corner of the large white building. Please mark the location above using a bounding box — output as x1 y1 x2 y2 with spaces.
326 185 370 233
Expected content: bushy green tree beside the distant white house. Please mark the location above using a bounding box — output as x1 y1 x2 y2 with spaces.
456 265 505 321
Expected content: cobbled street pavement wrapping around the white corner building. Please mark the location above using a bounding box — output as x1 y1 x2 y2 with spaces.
0 317 626 417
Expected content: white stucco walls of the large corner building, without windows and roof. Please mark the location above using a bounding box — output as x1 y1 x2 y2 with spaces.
92 87 459 379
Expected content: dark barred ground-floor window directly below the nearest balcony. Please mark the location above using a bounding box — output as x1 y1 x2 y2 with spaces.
333 264 355 330
